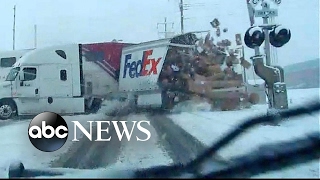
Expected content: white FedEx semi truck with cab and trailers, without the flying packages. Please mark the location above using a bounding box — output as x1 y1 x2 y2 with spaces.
0 33 262 120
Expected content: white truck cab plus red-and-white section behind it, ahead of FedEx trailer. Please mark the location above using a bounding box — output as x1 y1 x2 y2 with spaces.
0 42 140 120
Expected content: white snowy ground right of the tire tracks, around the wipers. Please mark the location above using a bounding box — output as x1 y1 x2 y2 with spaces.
171 88 320 178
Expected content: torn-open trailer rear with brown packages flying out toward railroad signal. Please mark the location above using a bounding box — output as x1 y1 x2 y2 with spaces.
159 27 266 111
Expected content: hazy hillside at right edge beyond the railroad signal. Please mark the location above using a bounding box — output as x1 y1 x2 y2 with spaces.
284 59 320 89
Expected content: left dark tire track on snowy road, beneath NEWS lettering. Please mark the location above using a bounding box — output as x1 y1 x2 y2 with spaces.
51 113 127 169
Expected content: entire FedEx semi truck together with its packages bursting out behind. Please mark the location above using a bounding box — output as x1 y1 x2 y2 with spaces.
0 18 272 119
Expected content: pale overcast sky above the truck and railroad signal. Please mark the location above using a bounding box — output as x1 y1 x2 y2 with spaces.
0 0 319 65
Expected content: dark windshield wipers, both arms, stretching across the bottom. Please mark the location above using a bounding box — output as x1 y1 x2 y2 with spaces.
9 102 320 178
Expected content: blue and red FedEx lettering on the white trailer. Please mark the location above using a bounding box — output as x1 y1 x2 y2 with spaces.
123 49 162 78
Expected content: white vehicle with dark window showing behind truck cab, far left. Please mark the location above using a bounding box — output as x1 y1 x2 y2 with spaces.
0 49 33 82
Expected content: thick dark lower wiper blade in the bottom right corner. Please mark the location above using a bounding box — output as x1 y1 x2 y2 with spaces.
201 132 320 178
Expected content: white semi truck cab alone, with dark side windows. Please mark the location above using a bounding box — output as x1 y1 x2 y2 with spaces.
0 44 84 119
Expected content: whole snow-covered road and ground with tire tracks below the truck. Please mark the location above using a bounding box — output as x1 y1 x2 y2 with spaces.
0 89 320 178
